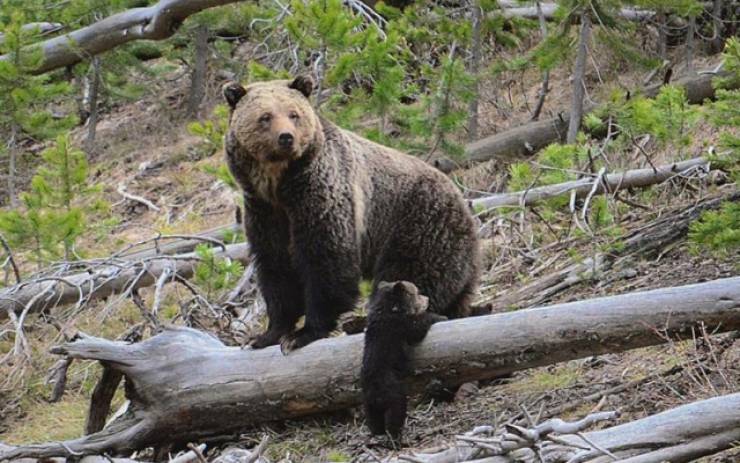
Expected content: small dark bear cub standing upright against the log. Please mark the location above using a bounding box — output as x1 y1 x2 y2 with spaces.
361 281 447 440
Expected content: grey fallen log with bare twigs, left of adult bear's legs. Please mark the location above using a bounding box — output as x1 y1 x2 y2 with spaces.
0 243 249 317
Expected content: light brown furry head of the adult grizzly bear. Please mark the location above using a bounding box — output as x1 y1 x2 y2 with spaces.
223 76 322 163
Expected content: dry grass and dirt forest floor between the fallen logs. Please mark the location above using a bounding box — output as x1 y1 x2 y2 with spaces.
0 36 740 462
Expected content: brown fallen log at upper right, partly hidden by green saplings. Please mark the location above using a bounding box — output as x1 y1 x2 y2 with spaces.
465 69 736 162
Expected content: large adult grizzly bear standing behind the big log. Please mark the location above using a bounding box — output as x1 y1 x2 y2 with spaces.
224 77 478 352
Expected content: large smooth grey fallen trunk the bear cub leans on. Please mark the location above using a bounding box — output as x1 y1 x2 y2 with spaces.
0 277 740 460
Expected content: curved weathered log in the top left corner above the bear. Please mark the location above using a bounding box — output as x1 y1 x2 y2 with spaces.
0 0 246 74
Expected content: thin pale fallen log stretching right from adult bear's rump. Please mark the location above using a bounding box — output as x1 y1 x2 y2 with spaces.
470 158 709 211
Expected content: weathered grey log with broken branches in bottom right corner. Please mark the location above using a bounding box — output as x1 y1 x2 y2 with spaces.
402 393 740 463
